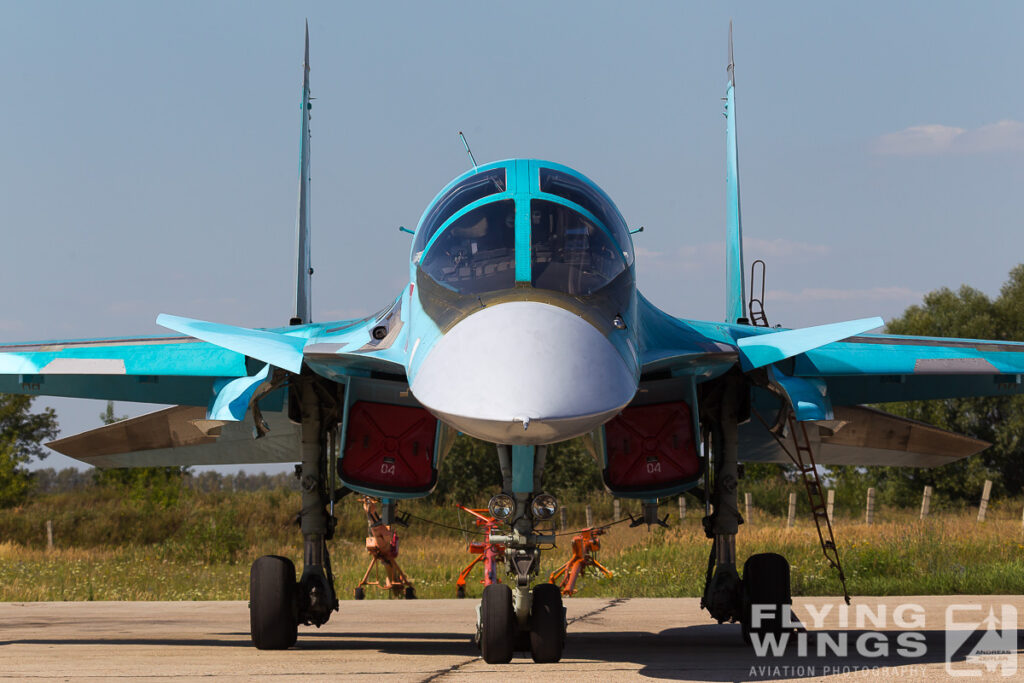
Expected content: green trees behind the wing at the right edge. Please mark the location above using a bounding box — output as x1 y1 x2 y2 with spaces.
840 264 1024 504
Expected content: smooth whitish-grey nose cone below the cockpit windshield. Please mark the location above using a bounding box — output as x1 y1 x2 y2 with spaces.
412 301 637 444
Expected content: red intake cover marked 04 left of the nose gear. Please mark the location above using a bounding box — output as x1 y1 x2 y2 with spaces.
340 400 437 493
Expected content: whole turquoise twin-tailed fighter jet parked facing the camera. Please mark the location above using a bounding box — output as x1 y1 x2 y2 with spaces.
8 25 1024 663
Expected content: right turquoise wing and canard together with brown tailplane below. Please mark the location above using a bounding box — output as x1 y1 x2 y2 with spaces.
640 298 1024 467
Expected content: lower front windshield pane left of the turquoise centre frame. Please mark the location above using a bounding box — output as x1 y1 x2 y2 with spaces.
420 200 515 294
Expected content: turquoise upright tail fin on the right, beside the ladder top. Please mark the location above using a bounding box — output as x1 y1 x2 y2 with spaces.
725 22 746 323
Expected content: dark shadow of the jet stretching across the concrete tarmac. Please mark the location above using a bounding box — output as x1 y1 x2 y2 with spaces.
0 625 1024 681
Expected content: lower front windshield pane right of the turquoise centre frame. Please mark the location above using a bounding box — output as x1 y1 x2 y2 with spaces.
529 200 627 295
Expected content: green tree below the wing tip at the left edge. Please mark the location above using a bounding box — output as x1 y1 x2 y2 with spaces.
0 394 60 507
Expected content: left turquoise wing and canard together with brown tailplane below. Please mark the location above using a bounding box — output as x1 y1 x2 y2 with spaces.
0 305 404 467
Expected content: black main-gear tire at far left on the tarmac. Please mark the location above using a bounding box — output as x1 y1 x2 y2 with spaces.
249 555 299 650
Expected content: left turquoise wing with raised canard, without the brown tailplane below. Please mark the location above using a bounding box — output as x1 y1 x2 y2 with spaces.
0 306 404 407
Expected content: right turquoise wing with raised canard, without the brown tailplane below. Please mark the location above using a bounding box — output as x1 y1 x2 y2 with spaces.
640 299 1024 405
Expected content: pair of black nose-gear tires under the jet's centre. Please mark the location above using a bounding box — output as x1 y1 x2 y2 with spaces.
476 584 565 664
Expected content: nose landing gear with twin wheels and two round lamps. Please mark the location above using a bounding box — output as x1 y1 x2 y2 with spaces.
476 445 565 664
